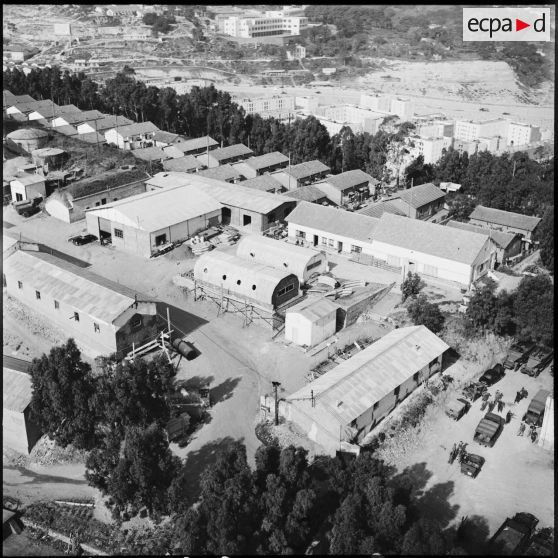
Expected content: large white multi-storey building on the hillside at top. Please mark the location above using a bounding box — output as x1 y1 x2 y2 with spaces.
219 12 308 39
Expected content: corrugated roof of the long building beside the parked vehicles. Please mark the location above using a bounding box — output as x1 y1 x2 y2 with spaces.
287 326 449 425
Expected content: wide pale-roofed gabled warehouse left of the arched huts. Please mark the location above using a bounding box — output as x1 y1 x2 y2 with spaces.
85 187 222 258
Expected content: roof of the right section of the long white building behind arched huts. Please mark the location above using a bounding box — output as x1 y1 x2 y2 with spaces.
374 213 488 264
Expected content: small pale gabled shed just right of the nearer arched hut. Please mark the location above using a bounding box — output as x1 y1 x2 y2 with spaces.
285 298 337 347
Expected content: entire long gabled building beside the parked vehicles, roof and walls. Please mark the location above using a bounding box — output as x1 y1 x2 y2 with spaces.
279 326 449 456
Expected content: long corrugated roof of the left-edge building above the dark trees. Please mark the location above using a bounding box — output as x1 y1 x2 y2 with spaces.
4 250 142 324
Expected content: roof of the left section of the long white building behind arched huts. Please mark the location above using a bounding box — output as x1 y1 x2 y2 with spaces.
286 202 379 242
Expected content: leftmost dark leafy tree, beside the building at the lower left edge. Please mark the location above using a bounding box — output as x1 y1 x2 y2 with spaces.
30 339 95 449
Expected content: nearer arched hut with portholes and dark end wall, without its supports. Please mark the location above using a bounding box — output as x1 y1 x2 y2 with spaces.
194 250 300 313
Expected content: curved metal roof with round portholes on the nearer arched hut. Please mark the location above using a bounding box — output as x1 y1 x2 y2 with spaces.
194 250 298 305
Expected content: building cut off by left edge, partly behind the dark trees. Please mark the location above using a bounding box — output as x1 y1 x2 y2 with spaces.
2 356 42 455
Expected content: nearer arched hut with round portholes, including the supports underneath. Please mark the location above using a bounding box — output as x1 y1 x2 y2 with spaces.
194 251 300 328
